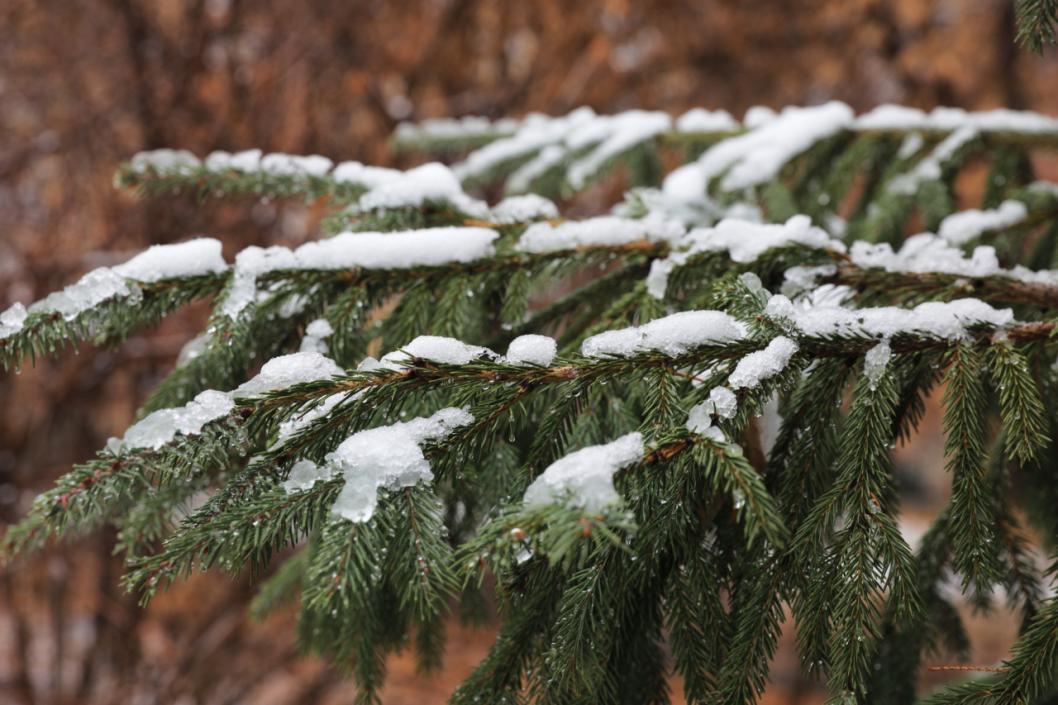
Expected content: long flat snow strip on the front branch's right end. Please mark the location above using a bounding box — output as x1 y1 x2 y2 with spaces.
766 294 1014 340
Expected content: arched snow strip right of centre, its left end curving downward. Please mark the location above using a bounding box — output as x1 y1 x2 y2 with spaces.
646 215 845 300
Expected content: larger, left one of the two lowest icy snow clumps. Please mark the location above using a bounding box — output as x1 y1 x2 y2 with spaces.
323 408 474 522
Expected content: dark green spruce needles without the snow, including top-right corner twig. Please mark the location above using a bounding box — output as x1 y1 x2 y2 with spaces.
6 104 1058 705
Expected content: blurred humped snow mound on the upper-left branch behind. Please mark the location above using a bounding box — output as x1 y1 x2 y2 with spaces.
357 162 489 218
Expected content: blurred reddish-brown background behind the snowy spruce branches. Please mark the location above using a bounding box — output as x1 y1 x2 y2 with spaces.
0 0 1058 705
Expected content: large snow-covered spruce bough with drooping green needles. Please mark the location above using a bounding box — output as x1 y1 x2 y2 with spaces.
6 103 1058 704
